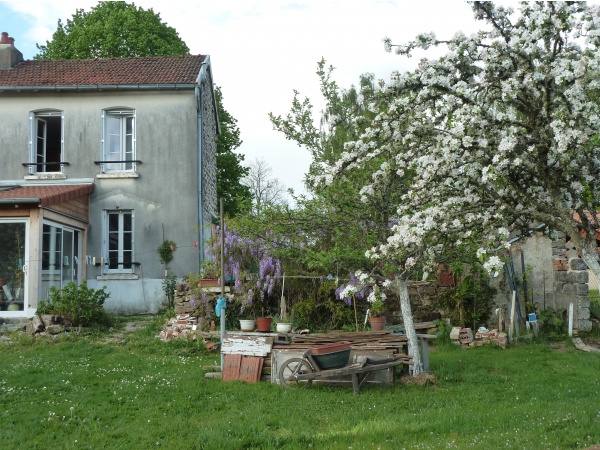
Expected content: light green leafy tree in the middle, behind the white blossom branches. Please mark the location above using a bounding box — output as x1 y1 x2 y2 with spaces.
268 59 403 276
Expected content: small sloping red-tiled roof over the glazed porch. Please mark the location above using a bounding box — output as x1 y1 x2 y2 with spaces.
0 184 94 206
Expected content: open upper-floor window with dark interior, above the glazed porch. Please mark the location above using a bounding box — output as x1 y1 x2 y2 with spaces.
29 111 64 174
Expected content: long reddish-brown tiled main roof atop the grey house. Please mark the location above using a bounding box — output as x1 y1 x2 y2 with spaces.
0 55 208 89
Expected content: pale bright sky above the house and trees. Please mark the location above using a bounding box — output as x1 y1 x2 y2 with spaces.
0 0 490 197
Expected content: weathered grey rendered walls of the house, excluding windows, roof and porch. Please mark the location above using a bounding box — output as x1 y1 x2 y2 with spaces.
0 89 217 313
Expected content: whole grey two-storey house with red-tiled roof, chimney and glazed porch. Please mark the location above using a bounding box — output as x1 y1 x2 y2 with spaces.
0 33 219 317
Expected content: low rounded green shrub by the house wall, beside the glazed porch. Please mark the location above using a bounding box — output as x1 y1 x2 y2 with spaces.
37 281 111 326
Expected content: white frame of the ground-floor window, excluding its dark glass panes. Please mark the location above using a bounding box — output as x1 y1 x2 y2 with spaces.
102 210 135 274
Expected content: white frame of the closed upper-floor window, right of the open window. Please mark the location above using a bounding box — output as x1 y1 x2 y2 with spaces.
100 108 137 173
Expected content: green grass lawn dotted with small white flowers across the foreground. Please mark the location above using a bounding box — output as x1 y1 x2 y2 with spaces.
0 321 600 449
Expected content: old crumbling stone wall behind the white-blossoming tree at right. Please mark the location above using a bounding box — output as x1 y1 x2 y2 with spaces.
400 231 600 331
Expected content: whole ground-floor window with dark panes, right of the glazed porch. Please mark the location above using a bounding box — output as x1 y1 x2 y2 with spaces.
103 211 134 273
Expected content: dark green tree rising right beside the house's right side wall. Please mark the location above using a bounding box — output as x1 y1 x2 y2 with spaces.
215 86 251 217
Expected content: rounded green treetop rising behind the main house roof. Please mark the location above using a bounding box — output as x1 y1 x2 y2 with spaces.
35 2 190 59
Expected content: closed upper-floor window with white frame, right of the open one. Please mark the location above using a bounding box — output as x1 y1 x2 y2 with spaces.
100 109 136 172
